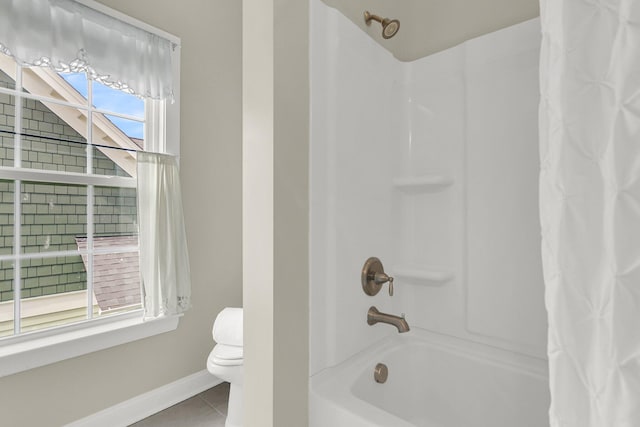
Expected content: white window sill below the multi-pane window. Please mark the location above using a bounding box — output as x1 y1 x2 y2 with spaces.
0 311 181 377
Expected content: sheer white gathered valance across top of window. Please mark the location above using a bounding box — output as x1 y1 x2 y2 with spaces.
0 0 175 99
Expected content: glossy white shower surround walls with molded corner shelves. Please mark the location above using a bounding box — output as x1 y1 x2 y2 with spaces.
310 0 547 384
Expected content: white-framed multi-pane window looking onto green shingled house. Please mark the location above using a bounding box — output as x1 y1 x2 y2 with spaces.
0 0 179 376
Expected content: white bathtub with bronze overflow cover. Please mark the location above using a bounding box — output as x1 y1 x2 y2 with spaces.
309 331 549 427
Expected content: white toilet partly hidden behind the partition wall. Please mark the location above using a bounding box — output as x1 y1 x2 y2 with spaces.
207 307 244 427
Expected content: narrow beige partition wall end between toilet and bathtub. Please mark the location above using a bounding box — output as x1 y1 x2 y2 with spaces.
242 0 309 427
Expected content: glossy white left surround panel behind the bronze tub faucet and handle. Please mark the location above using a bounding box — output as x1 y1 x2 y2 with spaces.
310 0 405 373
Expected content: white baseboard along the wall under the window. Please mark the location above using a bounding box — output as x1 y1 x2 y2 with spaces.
66 369 222 427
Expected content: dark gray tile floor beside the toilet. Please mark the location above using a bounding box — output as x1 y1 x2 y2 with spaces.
130 383 229 427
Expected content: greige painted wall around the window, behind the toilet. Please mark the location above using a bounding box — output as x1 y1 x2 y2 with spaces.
0 0 242 427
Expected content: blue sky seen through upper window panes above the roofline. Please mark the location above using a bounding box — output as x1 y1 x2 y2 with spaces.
60 73 144 139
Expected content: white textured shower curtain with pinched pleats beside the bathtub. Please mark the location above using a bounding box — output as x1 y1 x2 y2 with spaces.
540 0 640 427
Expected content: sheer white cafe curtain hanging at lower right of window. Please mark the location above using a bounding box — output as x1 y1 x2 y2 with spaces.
137 152 191 317
